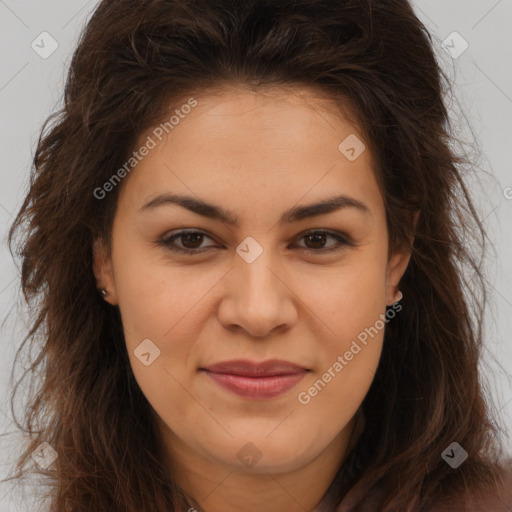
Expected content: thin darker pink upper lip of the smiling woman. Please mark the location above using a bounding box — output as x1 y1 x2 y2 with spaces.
200 359 308 377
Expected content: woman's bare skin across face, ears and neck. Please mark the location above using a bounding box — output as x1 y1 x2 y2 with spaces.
94 87 410 512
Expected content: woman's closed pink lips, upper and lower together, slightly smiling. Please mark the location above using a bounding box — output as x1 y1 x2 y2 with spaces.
200 359 308 400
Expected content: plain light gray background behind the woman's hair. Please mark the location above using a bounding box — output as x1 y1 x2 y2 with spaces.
0 0 512 512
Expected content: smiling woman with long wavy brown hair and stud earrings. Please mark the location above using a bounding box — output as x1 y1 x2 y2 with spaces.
5 0 512 512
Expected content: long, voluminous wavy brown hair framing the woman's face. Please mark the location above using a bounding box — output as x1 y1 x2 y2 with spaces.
5 0 508 512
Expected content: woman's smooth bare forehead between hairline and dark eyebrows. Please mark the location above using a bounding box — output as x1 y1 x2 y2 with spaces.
115 84 380 220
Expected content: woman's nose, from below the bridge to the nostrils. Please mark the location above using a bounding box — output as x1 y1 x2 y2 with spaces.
218 246 298 338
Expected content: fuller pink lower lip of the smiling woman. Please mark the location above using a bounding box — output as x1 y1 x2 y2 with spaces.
205 370 306 400
